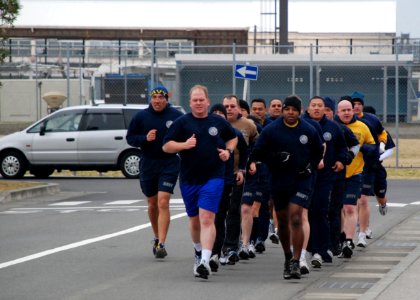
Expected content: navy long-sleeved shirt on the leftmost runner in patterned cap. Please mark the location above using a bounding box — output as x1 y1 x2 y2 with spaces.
126 105 183 159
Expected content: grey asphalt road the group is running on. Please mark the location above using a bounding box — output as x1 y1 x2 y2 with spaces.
0 177 420 300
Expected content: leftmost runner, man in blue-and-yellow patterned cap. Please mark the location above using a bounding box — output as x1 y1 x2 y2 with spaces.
126 86 182 258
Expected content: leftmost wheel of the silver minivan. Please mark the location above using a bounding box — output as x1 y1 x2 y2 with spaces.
0 151 27 179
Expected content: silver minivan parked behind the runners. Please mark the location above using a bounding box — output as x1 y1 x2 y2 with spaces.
0 104 183 179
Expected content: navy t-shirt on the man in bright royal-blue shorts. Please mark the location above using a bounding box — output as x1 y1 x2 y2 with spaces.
163 113 236 184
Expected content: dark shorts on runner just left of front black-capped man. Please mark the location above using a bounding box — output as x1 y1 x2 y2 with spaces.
241 164 270 205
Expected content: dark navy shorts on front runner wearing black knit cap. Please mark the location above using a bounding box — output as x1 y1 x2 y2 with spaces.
271 175 314 211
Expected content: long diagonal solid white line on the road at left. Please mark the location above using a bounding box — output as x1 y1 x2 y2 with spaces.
0 213 187 269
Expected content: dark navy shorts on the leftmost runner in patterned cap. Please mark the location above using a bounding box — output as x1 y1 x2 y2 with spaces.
139 156 180 197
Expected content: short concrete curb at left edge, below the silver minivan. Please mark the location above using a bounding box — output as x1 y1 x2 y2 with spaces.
0 183 60 203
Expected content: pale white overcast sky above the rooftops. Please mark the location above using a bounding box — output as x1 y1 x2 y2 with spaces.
15 0 420 38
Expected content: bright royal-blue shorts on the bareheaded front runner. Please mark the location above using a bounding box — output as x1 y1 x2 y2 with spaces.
179 178 224 217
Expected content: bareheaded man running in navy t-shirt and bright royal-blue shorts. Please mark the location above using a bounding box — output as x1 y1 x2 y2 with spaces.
163 85 238 279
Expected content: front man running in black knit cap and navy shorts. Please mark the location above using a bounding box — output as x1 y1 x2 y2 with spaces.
249 95 324 279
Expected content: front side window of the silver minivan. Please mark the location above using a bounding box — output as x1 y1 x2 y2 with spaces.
28 110 83 133
